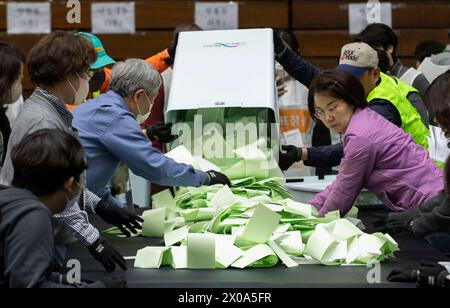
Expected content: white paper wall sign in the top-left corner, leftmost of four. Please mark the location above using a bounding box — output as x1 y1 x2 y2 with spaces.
6 2 52 34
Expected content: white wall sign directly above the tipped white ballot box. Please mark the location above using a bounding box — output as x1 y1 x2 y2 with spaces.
195 2 239 30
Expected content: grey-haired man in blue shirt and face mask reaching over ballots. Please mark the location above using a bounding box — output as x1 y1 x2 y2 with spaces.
73 59 230 209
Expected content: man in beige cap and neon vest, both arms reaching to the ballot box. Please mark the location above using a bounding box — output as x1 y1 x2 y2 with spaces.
274 35 429 170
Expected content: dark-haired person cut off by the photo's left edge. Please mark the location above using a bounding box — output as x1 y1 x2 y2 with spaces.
0 42 25 170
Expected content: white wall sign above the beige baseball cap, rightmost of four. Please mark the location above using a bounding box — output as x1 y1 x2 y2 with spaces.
348 0 392 34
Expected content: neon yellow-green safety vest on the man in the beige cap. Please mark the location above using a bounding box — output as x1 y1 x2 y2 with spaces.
367 73 430 149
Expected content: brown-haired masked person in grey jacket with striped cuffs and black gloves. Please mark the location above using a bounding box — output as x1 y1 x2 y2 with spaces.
0 31 142 271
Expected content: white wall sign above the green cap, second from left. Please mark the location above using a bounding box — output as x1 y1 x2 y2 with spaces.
91 2 136 34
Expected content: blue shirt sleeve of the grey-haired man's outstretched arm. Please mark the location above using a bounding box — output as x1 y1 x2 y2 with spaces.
100 114 207 186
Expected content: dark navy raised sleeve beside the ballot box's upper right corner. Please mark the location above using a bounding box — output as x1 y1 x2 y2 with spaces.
276 48 321 88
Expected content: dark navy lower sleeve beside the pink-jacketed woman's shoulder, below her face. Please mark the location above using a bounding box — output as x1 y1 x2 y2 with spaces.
303 143 344 168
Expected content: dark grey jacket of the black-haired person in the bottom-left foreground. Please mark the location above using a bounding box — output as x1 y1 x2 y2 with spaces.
0 187 104 288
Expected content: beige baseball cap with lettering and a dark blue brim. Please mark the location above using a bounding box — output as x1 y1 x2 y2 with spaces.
335 42 378 77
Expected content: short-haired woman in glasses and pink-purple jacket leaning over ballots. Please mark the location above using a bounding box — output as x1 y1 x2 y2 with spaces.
309 71 444 216
